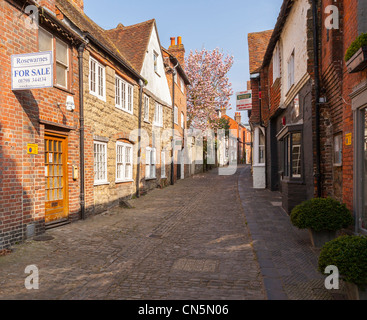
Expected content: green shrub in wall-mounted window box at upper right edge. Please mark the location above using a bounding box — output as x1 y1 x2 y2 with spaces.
345 33 367 73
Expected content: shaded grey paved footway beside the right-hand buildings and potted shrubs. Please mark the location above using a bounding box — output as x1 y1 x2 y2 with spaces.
238 167 346 300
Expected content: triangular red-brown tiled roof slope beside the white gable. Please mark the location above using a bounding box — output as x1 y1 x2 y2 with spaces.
104 19 155 72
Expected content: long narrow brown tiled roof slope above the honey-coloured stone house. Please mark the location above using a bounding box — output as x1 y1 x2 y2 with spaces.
56 0 140 78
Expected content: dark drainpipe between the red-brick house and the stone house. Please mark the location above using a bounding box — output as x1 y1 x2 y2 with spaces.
78 43 86 220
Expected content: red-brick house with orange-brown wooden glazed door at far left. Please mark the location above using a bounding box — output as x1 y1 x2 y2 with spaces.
0 0 84 249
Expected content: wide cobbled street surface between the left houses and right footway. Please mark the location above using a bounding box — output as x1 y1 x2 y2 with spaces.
0 171 266 300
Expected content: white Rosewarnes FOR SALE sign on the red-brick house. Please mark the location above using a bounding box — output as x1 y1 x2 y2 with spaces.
11 51 53 90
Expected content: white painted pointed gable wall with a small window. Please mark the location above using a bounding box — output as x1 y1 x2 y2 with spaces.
141 28 172 106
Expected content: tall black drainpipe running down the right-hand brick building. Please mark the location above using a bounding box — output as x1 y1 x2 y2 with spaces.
312 0 321 198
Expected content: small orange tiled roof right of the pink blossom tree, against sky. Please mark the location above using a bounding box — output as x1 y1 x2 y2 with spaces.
248 30 273 74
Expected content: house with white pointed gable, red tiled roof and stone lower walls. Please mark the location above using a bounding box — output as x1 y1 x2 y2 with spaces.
105 19 173 192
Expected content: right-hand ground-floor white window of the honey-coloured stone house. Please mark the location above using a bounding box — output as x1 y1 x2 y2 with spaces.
116 141 133 182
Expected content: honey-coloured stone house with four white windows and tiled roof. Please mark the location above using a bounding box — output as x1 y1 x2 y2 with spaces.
56 0 144 214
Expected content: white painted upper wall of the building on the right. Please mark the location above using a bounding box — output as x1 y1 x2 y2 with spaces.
280 0 311 103
